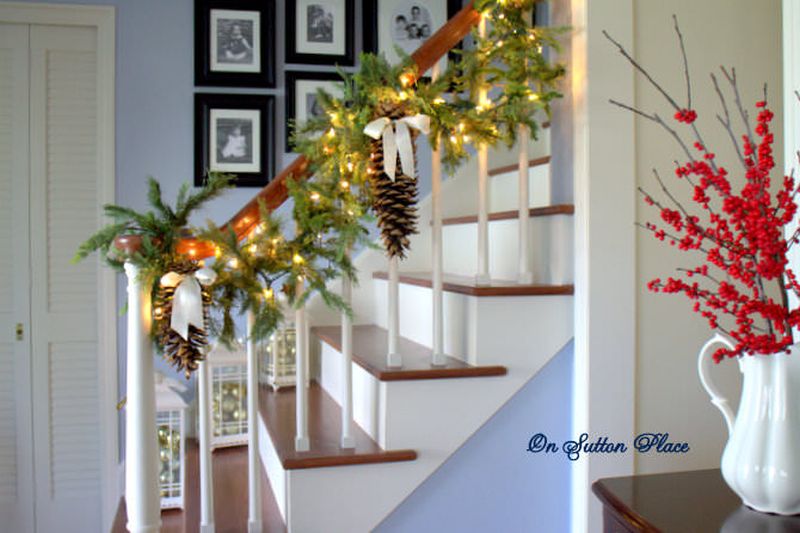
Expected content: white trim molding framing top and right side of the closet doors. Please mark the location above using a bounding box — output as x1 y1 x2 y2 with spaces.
0 2 122 530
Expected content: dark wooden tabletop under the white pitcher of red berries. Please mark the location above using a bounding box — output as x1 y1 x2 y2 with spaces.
592 469 800 533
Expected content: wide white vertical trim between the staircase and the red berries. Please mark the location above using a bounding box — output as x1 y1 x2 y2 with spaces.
564 0 636 533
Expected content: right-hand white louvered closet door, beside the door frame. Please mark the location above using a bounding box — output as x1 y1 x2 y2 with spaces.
30 25 104 533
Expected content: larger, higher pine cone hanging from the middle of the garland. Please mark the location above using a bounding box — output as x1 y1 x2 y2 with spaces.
370 102 418 259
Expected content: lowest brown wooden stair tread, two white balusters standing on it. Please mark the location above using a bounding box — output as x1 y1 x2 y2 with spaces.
258 382 417 470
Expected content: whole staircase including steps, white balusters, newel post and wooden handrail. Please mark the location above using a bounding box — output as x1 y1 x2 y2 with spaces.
116 4 574 533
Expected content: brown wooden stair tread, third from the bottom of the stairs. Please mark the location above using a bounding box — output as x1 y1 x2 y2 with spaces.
372 271 575 296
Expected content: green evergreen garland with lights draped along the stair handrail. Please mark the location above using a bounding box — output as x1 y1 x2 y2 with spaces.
75 0 565 368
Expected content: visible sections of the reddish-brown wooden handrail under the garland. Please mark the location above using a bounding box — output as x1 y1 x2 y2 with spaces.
114 2 481 259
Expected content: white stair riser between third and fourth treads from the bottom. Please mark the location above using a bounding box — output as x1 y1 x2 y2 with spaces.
442 215 574 285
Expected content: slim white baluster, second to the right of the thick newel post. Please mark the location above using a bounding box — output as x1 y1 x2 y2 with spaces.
247 311 262 533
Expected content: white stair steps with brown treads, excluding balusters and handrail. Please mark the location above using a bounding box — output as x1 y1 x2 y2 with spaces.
259 138 574 533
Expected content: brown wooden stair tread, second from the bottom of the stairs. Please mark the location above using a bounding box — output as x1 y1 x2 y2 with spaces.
312 325 507 381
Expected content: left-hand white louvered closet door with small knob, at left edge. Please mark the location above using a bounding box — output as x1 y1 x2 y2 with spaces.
0 24 33 533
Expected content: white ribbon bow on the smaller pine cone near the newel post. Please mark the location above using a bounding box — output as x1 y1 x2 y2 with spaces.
161 267 217 340
